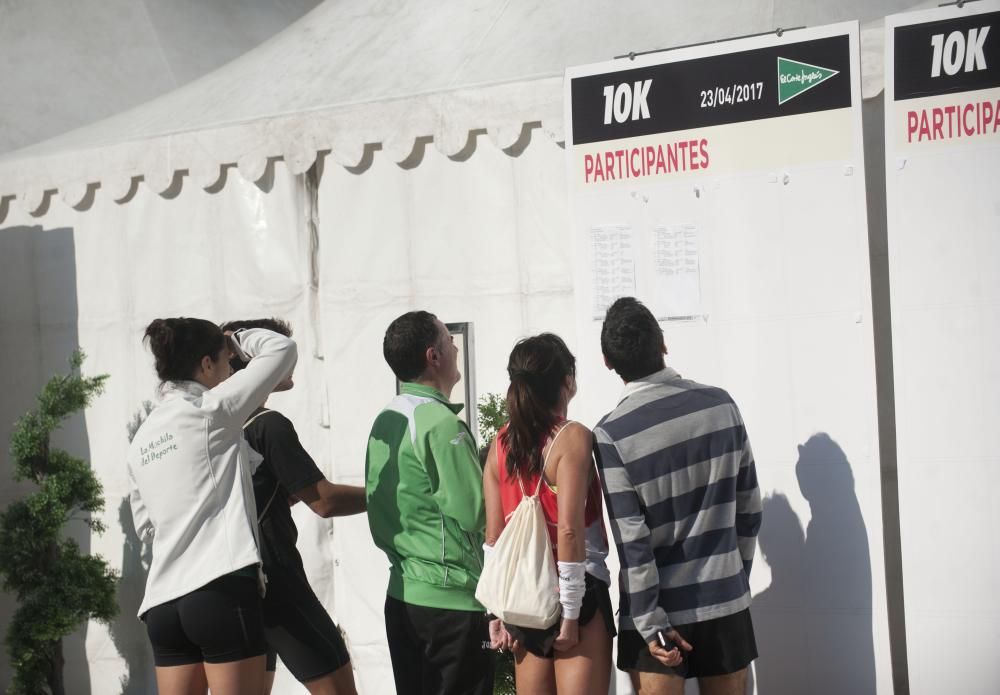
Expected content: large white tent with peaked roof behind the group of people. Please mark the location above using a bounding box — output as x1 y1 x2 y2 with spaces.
0 0 927 693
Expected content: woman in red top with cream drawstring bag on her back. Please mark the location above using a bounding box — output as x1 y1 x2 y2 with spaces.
477 333 615 695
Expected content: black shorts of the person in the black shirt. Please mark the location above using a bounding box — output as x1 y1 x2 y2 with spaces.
264 565 351 683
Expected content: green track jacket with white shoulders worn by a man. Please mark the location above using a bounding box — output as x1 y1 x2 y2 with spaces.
365 383 486 611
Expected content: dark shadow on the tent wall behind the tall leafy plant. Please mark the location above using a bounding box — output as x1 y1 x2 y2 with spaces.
0 226 90 695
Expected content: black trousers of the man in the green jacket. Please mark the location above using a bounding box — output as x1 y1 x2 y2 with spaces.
385 596 495 695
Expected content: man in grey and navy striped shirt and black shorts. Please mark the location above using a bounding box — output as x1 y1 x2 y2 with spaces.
594 297 761 695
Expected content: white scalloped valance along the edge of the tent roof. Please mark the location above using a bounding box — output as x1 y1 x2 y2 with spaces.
0 77 563 222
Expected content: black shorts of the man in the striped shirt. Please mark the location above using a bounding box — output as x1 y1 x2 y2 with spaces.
618 608 757 678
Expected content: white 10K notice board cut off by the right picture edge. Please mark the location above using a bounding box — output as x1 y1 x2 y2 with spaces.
885 0 1000 695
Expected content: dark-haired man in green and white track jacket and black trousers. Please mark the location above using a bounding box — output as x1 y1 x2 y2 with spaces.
365 311 493 695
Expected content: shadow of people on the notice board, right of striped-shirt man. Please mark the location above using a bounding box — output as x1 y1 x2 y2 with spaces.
751 432 875 695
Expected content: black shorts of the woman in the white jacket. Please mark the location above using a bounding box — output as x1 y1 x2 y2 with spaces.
143 568 267 666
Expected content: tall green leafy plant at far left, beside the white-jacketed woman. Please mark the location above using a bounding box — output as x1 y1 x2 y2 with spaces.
0 350 117 695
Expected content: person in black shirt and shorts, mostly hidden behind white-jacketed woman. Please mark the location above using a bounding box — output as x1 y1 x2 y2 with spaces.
223 319 365 695
